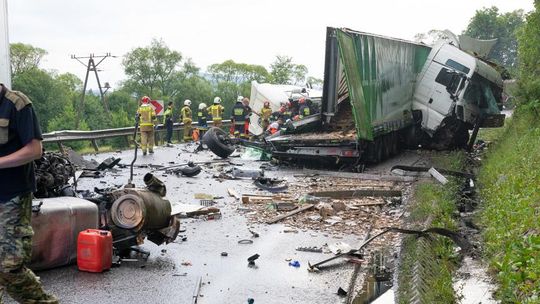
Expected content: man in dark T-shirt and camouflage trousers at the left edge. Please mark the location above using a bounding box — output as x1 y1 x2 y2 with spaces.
0 84 58 303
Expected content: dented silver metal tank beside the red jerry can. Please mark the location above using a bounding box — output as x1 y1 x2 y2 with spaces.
29 197 98 270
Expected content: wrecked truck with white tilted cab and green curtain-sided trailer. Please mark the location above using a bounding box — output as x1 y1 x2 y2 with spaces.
211 27 504 163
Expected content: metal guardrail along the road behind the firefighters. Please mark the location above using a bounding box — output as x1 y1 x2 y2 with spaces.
43 120 231 152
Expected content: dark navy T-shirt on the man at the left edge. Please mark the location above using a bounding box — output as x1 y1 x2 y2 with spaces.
0 84 43 203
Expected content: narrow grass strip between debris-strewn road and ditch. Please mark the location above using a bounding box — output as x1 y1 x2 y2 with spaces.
398 152 465 303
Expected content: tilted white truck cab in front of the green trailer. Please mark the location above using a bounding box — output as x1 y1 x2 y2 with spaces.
413 42 504 136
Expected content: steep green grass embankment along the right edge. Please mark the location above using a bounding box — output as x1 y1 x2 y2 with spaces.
478 113 540 303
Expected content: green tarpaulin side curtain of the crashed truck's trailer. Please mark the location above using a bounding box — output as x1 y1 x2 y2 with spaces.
336 29 431 140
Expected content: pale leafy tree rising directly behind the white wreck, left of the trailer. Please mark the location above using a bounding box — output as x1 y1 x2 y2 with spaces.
270 55 308 84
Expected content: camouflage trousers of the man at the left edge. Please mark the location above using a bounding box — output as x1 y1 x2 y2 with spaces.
0 193 58 304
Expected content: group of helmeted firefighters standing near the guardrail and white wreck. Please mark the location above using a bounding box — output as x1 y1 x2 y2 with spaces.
137 96 313 155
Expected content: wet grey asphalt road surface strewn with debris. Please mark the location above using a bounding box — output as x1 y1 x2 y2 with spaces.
21 145 392 304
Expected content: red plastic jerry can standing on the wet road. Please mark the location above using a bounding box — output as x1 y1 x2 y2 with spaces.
77 229 112 272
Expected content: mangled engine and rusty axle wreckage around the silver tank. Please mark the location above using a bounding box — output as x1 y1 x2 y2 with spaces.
34 152 180 255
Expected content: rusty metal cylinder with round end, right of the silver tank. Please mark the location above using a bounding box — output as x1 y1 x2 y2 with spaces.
110 188 171 230
